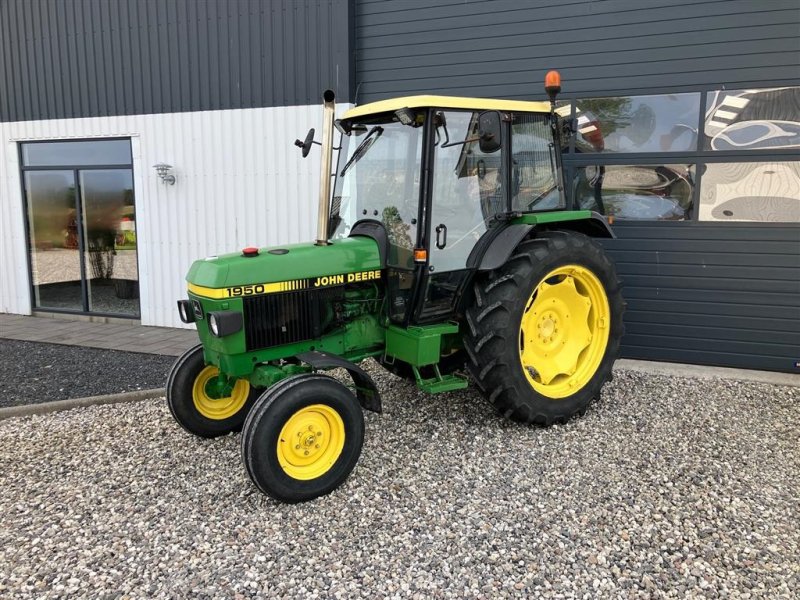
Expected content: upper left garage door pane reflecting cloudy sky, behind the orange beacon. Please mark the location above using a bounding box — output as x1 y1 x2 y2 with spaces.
575 93 700 152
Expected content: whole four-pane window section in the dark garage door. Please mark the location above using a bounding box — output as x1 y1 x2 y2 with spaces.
564 87 800 223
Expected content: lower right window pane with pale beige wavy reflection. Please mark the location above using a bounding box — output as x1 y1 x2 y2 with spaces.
699 162 800 223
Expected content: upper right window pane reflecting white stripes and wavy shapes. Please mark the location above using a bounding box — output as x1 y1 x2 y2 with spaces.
704 87 800 150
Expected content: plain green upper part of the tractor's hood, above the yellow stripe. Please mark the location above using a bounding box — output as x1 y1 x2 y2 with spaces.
186 237 381 288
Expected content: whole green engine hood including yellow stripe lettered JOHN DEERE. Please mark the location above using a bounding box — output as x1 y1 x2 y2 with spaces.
186 237 381 298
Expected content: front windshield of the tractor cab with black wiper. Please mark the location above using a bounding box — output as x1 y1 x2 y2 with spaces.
331 115 423 268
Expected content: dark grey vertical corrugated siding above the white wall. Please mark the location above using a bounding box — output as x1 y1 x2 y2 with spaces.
0 0 352 121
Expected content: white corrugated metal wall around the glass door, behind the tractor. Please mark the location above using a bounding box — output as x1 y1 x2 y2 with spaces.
0 105 347 326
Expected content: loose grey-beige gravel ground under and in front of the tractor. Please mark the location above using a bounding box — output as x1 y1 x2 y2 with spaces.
0 366 800 599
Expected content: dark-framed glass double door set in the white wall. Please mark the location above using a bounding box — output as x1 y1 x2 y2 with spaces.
21 139 139 317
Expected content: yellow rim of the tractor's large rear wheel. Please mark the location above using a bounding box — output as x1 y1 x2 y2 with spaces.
519 265 611 398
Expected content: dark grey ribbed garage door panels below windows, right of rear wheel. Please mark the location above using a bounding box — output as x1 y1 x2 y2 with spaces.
605 222 800 371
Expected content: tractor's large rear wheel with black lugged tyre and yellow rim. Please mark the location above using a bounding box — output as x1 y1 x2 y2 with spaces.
465 231 625 426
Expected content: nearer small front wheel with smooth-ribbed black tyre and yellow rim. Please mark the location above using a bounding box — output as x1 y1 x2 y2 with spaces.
242 374 364 503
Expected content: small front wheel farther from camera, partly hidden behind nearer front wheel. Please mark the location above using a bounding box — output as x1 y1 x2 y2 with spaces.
167 345 258 438
